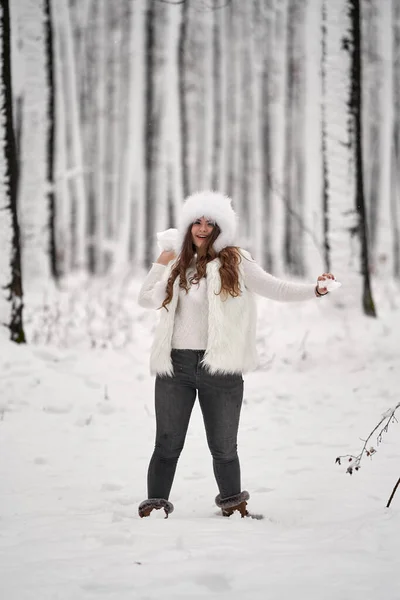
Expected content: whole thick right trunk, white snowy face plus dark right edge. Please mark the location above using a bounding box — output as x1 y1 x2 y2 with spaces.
324 0 375 316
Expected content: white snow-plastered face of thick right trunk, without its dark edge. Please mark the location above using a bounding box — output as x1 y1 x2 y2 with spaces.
322 0 362 304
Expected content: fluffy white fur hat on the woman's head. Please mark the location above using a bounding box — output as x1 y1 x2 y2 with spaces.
176 190 237 252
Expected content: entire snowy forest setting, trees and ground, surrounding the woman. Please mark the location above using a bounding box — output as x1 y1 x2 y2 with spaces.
0 0 400 600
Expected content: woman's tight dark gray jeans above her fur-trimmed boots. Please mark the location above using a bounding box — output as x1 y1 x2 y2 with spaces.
147 350 243 500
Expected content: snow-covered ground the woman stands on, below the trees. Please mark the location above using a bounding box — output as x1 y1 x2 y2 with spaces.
0 276 400 600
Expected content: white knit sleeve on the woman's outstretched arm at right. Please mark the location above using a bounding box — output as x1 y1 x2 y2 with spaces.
242 257 315 302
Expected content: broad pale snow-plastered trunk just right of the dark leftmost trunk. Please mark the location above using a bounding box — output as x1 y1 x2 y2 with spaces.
19 0 50 287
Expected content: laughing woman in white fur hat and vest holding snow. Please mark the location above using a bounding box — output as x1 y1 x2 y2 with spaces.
139 192 334 518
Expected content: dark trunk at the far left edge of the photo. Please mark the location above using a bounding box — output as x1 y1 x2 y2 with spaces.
0 0 25 343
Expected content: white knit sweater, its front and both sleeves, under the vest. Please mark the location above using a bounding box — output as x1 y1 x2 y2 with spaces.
139 259 315 350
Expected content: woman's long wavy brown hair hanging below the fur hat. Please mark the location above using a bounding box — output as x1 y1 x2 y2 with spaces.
161 224 241 310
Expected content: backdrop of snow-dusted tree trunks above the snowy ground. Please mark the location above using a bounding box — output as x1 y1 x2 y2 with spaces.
0 0 400 341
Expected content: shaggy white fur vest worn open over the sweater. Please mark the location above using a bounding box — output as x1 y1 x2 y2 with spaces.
150 250 258 375
